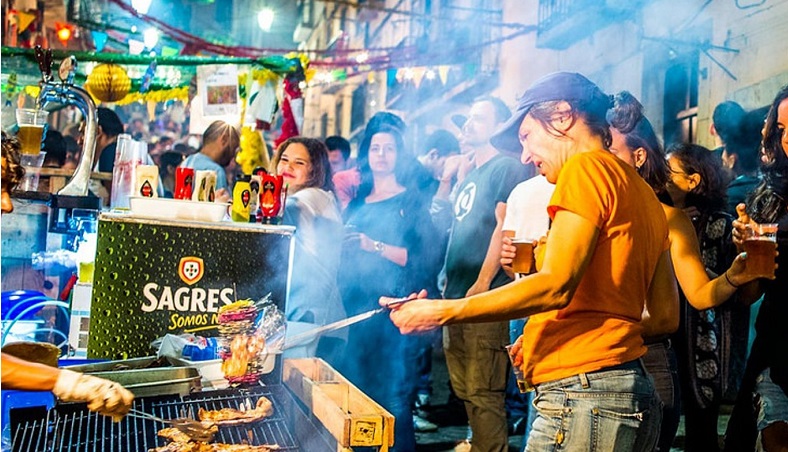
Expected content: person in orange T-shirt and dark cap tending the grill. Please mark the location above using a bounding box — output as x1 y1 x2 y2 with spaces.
381 72 678 451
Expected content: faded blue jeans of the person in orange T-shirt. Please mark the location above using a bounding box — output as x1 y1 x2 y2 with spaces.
525 360 662 452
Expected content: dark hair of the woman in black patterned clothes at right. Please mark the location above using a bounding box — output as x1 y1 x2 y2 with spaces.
668 143 727 213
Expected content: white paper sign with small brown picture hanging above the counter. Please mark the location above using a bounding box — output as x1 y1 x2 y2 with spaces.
197 64 240 116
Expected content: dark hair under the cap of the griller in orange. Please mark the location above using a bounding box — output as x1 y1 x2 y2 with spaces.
529 96 613 149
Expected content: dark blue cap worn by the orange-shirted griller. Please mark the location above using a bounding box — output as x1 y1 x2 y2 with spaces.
490 72 612 154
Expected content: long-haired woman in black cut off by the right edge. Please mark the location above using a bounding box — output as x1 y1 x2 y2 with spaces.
725 86 788 451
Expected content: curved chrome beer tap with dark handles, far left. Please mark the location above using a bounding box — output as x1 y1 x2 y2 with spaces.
35 46 98 196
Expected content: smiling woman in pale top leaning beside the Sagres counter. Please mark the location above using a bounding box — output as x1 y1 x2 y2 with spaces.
272 137 346 364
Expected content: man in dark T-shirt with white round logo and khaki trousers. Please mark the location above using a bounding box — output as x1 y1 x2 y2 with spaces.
443 97 527 451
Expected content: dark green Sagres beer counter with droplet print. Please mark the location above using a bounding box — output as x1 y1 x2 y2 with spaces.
87 214 294 359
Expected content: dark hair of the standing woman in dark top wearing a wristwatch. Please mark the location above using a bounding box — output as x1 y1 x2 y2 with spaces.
356 124 418 200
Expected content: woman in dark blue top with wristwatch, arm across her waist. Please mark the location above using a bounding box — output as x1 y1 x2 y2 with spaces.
340 123 435 451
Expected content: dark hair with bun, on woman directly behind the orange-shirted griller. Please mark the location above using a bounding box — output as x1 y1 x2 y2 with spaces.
607 91 670 194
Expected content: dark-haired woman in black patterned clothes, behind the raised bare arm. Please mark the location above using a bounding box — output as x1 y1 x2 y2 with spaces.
666 144 747 451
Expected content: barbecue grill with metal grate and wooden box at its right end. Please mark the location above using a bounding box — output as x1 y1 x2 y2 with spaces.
10 359 393 452
